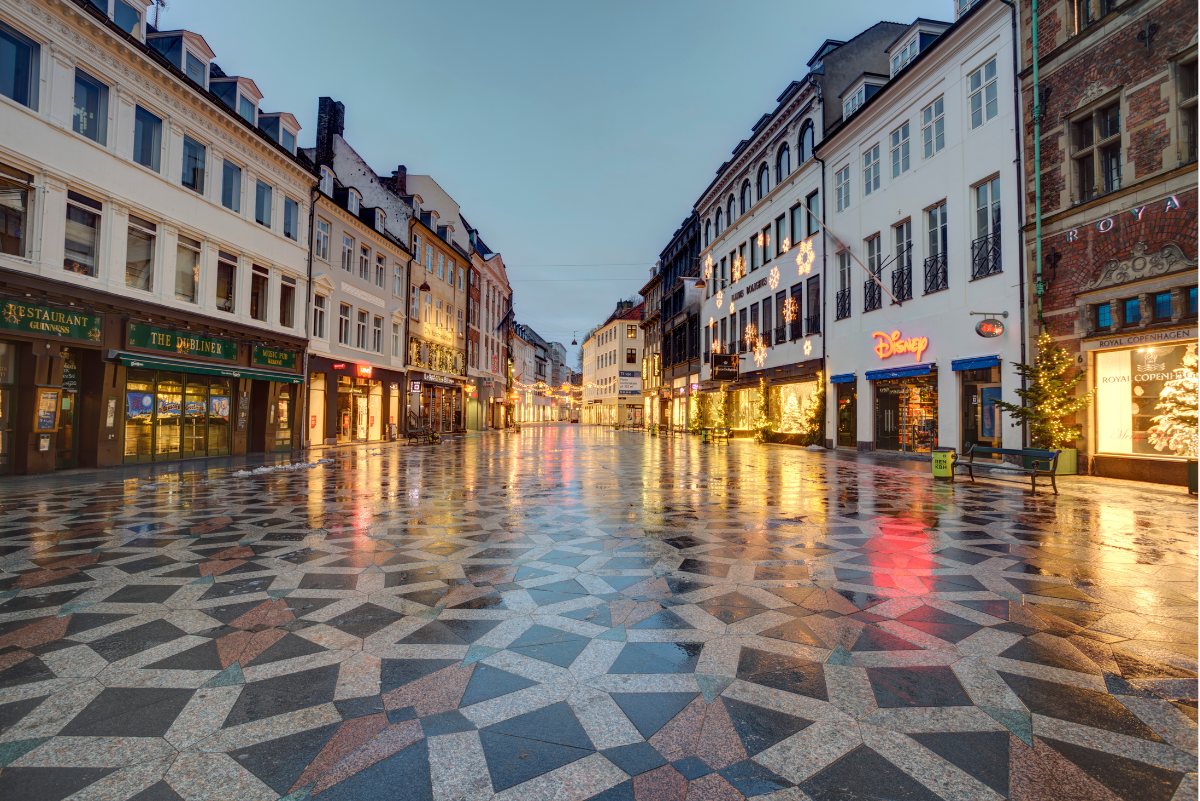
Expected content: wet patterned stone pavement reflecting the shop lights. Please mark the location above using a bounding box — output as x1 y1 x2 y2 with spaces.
0 426 1198 801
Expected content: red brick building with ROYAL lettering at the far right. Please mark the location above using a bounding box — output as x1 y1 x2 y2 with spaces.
1021 0 1198 483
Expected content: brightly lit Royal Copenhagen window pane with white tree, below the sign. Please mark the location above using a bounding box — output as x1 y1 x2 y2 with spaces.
1096 342 1196 457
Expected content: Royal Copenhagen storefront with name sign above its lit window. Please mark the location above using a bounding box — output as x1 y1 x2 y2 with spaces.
1084 327 1198 484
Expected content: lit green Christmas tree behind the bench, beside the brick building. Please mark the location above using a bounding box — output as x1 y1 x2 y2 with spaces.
996 332 1092 451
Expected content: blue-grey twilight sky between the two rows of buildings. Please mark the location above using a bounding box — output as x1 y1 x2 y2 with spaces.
161 0 954 366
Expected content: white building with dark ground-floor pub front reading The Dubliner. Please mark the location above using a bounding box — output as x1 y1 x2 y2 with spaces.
0 0 316 474
